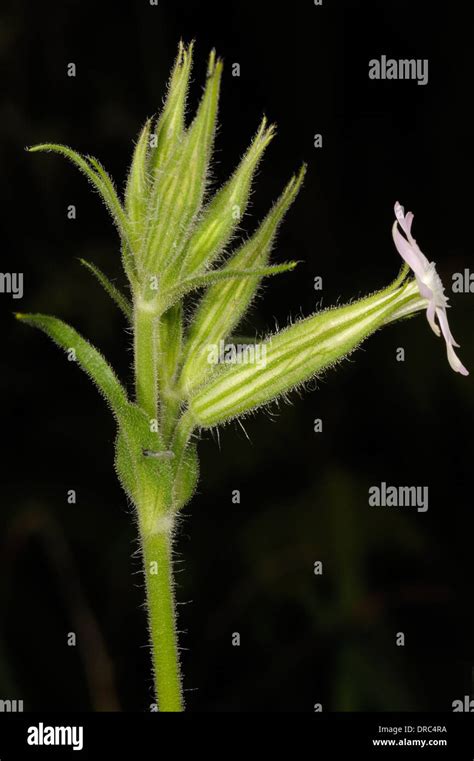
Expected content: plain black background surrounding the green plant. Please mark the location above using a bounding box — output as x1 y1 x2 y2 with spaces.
0 0 474 711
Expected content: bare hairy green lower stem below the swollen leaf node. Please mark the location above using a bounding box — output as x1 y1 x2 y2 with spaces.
142 528 183 712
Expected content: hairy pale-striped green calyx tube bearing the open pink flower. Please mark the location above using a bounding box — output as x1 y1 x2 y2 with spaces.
188 282 423 428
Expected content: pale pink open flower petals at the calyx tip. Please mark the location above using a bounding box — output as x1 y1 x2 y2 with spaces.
392 201 469 375
